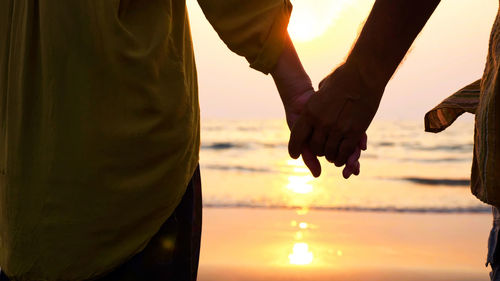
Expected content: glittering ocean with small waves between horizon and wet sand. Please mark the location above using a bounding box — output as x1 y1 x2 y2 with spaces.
200 118 490 213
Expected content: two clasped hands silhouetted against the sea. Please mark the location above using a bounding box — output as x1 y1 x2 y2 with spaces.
277 61 379 178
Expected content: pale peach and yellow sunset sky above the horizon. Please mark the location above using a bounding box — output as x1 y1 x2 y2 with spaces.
187 0 498 120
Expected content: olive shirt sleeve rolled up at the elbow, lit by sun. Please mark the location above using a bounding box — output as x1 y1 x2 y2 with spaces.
198 0 292 74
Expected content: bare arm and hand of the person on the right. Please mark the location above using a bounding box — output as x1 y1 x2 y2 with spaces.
289 0 440 166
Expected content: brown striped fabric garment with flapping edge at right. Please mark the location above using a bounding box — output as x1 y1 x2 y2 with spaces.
425 7 500 207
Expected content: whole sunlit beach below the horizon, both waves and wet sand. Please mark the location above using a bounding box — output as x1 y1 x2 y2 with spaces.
199 117 492 281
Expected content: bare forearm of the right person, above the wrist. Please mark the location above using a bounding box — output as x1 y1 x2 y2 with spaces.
346 0 440 92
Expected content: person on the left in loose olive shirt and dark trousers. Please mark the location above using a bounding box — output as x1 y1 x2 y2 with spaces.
0 0 359 281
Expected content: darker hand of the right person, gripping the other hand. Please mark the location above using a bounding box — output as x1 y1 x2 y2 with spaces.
289 61 383 167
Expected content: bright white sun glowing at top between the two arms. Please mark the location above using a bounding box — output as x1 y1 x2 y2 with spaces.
288 0 349 42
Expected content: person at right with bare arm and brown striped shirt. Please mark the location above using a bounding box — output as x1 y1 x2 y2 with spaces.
289 0 500 280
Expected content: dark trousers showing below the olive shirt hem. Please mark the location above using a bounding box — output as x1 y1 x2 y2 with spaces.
0 168 202 281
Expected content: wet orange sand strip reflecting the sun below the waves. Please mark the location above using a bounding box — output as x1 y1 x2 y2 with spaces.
199 208 491 281
